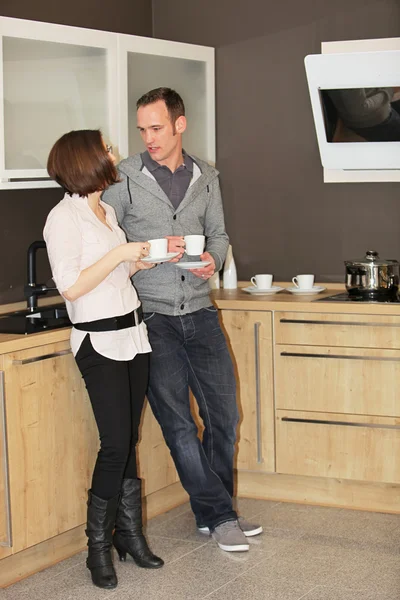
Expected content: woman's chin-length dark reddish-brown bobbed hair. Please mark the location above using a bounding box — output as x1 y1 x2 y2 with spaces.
47 129 119 196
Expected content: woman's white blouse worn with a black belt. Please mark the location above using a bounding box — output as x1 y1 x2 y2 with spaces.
43 194 151 360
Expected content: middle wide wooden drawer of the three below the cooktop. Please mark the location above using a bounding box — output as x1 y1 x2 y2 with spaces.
275 345 400 416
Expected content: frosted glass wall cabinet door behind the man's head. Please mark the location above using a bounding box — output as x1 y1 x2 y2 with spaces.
118 35 215 163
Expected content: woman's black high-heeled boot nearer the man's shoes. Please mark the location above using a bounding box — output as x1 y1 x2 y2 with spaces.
113 479 164 569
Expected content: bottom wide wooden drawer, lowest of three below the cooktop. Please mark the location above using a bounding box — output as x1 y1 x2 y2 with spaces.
276 410 400 483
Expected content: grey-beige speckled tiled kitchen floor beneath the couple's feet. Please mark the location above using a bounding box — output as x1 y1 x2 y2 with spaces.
0 499 400 600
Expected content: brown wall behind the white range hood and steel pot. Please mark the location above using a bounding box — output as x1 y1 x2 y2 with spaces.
153 0 400 281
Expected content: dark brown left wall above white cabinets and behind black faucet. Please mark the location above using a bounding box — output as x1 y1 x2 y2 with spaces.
0 0 152 304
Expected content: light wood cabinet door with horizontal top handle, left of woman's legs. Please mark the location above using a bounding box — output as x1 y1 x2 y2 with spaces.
4 342 98 553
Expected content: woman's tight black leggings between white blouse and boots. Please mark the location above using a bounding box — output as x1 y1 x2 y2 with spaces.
75 335 149 500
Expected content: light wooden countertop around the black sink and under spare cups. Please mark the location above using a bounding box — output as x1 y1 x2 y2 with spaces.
0 282 400 354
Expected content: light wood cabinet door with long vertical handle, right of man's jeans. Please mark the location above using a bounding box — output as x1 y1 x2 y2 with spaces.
221 310 275 472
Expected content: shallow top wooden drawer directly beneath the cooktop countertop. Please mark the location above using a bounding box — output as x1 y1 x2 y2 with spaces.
275 312 400 349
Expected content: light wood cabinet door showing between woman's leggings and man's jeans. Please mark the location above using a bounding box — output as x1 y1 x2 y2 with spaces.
138 401 179 496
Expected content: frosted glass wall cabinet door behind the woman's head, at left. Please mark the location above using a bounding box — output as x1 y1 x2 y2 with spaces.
0 18 118 187
